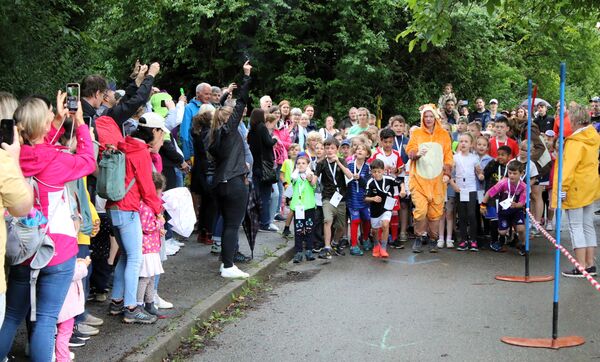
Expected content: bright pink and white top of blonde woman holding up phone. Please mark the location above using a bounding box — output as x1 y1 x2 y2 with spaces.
20 125 96 266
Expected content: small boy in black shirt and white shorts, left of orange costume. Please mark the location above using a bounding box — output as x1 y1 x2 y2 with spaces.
365 159 406 258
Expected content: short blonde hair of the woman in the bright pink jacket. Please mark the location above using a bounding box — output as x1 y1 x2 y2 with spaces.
14 98 48 146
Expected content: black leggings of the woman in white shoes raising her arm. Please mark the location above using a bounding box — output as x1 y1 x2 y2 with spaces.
215 175 248 268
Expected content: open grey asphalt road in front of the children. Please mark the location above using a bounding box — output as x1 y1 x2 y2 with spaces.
191 217 600 362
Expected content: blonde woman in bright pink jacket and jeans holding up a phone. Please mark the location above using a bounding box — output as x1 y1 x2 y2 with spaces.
0 92 96 361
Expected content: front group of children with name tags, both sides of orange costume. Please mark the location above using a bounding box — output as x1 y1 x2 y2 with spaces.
280 116 527 263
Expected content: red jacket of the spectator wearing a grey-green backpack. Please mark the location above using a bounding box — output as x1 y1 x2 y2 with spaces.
106 136 162 214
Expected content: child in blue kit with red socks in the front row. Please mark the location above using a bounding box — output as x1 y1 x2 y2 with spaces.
346 144 371 256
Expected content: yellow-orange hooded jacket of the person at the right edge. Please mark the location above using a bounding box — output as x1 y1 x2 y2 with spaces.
552 125 600 210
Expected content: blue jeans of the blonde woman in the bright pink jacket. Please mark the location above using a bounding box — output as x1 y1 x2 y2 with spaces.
0 257 76 362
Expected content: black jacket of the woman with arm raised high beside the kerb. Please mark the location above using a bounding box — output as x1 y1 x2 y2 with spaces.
209 76 251 186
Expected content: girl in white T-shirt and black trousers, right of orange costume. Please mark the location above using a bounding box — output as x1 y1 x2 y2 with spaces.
454 133 483 251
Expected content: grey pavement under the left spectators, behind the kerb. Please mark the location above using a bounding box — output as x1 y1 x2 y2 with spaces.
7 229 285 362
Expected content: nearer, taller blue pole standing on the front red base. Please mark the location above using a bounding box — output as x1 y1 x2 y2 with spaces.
552 62 567 339
